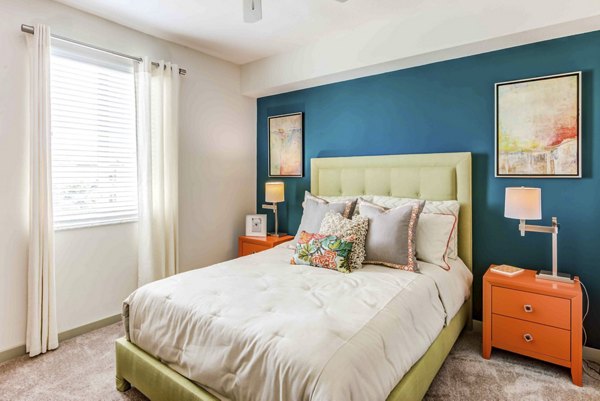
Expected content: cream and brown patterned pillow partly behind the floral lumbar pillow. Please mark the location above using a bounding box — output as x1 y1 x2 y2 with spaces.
319 212 369 270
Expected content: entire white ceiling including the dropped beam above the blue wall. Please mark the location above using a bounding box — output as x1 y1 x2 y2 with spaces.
55 0 600 97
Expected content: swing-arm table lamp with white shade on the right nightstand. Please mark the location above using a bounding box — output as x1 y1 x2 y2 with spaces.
504 187 573 283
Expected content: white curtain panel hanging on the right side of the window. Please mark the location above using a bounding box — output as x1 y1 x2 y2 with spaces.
136 58 179 285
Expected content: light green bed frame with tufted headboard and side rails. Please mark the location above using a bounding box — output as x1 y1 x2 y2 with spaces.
116 153 472 401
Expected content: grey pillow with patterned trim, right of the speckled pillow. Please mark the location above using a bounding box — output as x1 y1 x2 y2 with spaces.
358 200 425 271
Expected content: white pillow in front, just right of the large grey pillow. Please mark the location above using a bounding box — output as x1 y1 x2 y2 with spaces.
416 213 456 270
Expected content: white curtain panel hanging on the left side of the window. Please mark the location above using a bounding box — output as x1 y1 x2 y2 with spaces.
26 25 58 356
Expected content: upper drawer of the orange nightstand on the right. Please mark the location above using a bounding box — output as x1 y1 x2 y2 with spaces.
492 286 571 330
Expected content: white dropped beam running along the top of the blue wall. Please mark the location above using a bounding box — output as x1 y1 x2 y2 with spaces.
242 0 600 97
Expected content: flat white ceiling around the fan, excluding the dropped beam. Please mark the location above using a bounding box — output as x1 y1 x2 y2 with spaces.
52 0 426 64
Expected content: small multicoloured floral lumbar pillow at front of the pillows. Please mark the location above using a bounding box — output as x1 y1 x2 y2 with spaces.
290 231 354 273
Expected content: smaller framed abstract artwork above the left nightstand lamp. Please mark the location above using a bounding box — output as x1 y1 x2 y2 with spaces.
268 113 304 177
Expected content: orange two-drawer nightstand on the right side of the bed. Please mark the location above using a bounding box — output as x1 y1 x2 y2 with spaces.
483 270 582 386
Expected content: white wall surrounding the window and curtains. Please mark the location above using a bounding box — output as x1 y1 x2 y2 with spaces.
0 0 256 352
